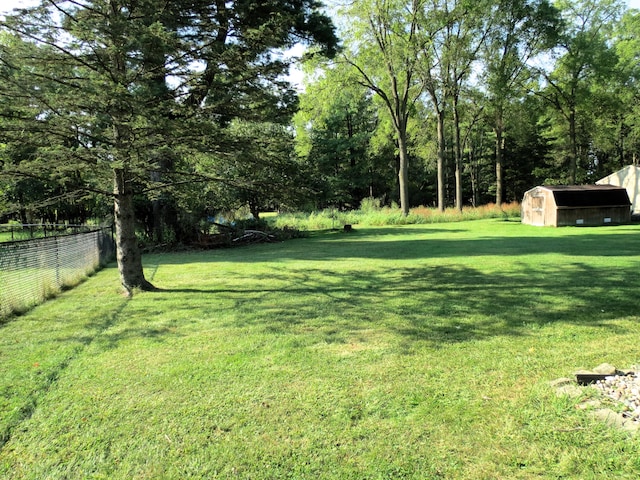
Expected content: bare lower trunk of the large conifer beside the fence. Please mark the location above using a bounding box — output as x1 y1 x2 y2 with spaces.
114 169 155 295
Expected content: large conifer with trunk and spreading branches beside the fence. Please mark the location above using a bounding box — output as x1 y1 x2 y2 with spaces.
0 0 336 292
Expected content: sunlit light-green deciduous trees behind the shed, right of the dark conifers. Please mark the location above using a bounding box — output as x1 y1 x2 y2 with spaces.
295 0 640 212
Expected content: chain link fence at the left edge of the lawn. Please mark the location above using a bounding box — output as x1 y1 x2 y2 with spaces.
0 228 115 317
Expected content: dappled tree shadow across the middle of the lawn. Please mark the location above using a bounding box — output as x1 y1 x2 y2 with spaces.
148 262 640 347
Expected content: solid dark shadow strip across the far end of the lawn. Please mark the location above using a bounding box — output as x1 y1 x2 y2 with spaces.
151 225 640 265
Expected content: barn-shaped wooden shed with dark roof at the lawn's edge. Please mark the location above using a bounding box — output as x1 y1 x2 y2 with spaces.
522 185 631 227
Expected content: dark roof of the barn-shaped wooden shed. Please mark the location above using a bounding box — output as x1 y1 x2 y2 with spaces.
542 185 631 207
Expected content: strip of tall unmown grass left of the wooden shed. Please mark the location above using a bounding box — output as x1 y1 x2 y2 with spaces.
269 198 520 231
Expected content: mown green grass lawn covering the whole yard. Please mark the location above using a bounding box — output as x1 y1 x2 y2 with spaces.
0 220 640 480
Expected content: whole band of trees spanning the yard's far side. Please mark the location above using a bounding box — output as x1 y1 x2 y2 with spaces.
0 0 640 255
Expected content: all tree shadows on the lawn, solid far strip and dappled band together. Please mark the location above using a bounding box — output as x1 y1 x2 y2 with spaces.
55 224 640 348
